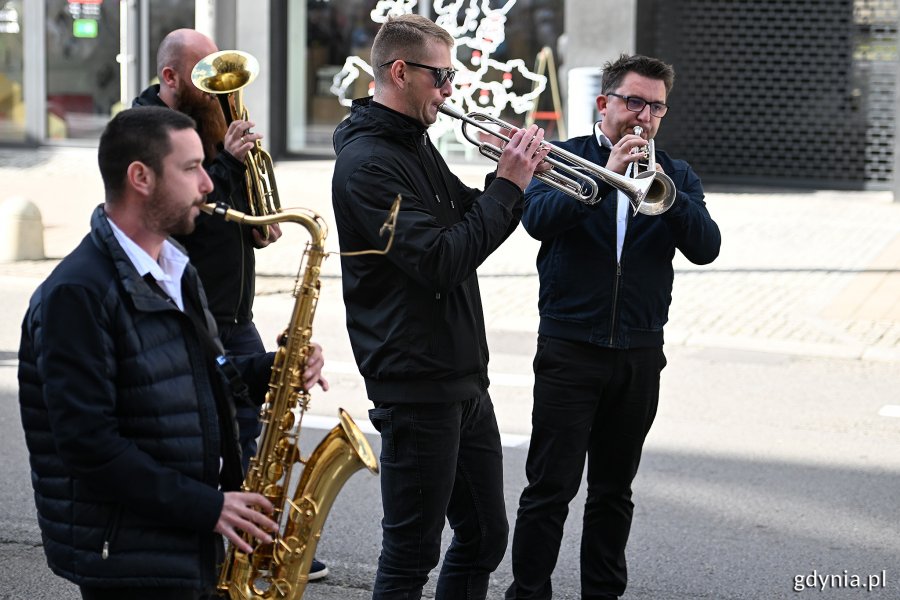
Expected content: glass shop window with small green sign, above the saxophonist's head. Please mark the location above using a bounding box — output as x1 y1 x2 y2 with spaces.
46 0 121 140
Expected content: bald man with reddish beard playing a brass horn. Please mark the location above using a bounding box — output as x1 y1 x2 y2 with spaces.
132 29 328 580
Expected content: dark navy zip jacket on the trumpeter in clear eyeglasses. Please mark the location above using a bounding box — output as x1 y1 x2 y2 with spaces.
522 135 721 348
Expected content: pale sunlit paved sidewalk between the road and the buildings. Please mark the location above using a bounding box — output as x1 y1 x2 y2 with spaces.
0 148 900 362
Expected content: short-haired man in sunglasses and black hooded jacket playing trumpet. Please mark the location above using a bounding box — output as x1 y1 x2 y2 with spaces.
332 14 547 600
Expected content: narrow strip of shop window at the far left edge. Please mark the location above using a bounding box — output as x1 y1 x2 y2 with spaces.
0 0 25 142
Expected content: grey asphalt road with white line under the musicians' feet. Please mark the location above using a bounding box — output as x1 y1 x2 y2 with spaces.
0 333 900 600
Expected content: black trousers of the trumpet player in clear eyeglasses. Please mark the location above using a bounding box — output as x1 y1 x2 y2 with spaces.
506 336 666 600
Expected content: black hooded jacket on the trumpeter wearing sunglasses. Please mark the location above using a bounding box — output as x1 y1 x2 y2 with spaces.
332 99 522 402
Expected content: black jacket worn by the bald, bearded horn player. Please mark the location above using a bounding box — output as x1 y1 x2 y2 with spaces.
132 84 256 326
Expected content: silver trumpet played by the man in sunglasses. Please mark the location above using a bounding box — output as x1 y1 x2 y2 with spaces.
439 104 674 214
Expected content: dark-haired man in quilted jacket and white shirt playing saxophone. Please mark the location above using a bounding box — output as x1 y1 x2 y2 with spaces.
18 107 321 600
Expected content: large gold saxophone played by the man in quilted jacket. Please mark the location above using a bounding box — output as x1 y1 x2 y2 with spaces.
201 199 378 600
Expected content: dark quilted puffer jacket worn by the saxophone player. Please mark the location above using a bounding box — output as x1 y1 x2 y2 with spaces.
19 206 272 588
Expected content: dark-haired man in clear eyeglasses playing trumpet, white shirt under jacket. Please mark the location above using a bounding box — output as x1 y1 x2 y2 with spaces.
506 55 721 600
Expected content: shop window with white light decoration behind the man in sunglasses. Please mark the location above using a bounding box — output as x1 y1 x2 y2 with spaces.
286 0 564 154
